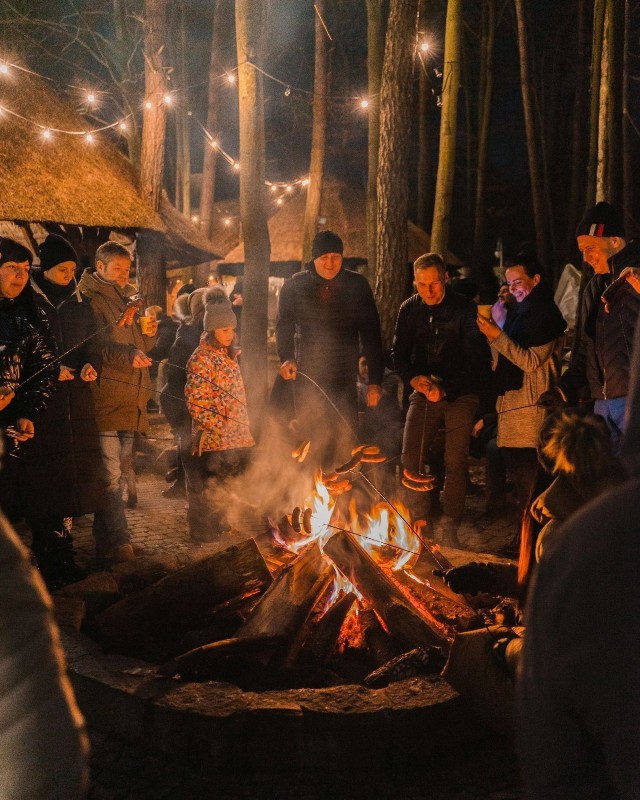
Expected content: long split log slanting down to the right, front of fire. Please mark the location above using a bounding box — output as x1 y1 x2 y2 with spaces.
324 531 447 648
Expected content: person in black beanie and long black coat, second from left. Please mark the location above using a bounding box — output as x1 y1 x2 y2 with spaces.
19 233 106 591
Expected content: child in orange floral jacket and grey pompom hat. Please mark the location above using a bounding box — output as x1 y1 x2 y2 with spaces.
185 286 255 542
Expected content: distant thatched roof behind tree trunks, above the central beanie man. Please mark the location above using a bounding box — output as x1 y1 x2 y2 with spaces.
224 178 462 266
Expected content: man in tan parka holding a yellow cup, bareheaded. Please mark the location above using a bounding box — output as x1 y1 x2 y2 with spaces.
78 242 158 561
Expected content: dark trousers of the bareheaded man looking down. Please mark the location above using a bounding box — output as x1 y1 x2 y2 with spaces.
402 392 479 522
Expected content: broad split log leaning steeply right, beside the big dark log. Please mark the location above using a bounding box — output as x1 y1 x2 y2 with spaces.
236 542 333 664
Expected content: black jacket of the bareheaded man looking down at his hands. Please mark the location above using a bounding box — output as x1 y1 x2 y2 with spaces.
392 286 490 402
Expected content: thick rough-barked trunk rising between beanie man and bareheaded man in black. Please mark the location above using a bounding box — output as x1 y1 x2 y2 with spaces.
375 0 418 345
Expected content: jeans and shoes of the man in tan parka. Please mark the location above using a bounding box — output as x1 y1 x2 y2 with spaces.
93 431 135 556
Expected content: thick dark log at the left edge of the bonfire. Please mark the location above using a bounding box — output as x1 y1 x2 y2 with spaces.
96 539 272 658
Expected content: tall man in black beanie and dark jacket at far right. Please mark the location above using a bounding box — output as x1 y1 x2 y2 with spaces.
539 202 640 452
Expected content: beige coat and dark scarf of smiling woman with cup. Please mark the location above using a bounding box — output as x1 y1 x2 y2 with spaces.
491 284 565 447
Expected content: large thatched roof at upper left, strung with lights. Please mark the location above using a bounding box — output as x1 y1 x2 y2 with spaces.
0 71 164 231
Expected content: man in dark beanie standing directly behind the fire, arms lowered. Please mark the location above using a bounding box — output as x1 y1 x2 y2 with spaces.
276 231 383 466
